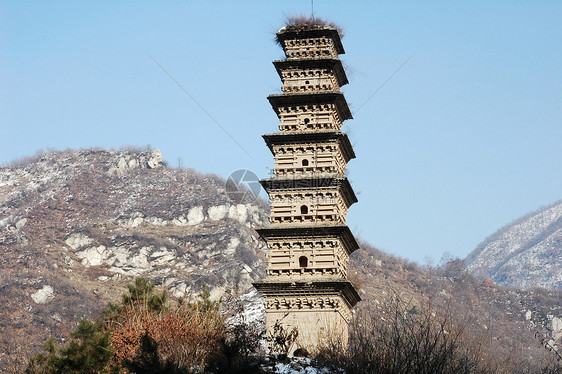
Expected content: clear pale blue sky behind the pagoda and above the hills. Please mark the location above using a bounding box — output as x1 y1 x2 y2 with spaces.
0 0 562 263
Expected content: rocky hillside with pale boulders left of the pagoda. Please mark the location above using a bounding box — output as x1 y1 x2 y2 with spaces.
0 150 267 366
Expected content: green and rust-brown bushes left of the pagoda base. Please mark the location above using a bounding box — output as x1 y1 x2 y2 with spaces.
26 278 259 374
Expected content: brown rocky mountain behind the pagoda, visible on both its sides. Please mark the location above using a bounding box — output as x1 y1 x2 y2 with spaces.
0 149 562 372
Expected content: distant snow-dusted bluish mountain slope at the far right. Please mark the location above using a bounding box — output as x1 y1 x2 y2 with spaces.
466 201 562 290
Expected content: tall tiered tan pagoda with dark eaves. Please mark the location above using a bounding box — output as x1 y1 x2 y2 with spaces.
254 24 360 355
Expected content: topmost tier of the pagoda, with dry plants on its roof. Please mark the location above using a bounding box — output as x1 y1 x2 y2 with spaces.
277 18 345 59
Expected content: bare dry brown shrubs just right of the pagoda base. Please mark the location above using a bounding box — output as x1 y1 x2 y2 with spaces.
320 295 503 374
